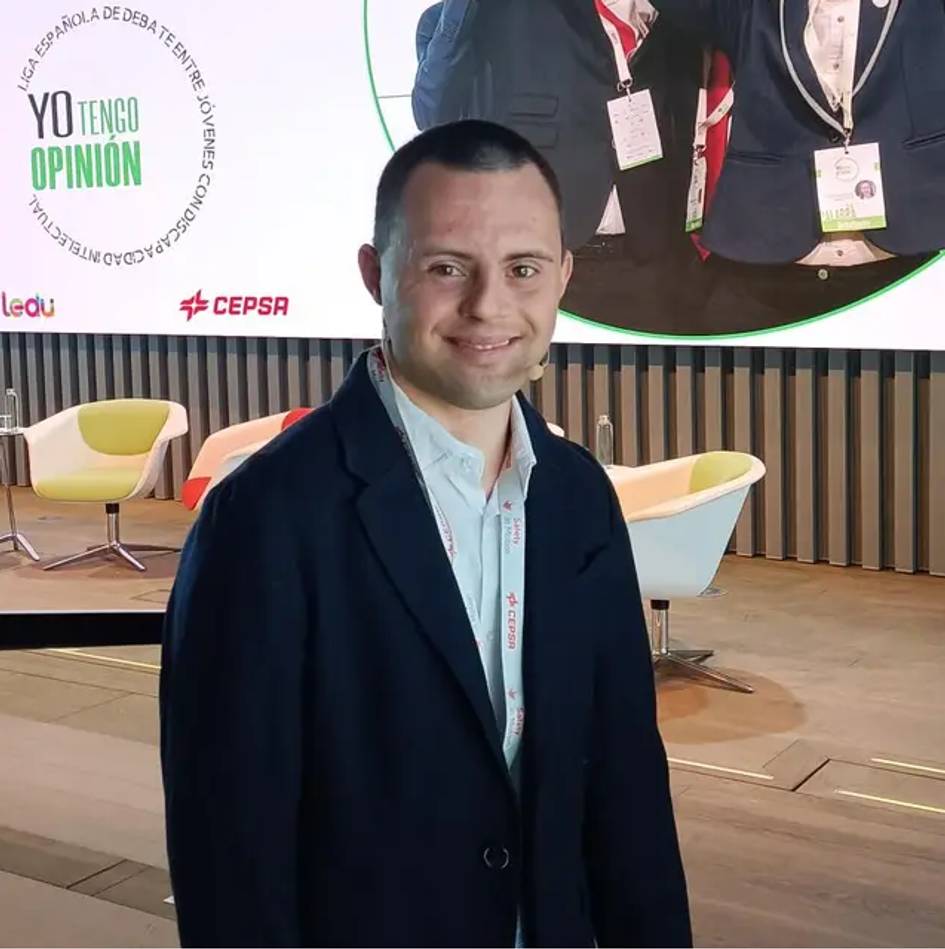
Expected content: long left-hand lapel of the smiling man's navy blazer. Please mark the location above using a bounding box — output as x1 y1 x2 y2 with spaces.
331 355 508 777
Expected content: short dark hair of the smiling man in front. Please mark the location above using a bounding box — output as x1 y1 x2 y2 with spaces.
374 119 562 254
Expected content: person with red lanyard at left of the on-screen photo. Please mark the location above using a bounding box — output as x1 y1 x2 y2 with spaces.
412 0 709 333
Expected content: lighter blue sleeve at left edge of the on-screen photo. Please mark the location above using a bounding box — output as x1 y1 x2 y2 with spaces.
411 0 478 130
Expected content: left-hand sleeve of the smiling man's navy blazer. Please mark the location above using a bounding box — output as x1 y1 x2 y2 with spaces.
160 478 304 946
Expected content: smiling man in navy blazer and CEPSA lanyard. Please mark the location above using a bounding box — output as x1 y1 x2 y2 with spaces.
161 122 690 946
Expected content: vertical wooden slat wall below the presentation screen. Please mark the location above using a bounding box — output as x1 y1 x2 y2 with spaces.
0 333 945 576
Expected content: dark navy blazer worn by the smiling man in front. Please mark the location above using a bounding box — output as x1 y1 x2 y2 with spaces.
160 357 691 946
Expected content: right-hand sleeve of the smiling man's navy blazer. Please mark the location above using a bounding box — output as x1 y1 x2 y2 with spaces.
585 483 692 946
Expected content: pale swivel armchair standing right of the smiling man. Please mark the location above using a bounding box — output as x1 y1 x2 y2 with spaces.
607 451 765 692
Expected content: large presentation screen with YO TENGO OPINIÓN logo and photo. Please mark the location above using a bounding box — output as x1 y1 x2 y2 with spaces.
0 0 945 349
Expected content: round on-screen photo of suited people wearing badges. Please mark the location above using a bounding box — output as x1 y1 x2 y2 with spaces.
366 0 945 336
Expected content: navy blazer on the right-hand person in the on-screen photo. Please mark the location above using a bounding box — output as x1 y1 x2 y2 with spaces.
653 0 945 263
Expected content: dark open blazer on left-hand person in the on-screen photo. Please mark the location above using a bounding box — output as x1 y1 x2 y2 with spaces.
412 0 702 260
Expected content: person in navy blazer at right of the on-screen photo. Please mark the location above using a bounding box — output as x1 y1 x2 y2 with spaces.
653 0 945 325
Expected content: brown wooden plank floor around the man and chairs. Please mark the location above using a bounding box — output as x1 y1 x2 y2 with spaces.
0 492 945 947
